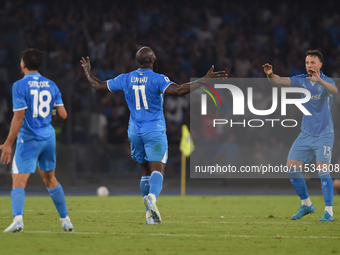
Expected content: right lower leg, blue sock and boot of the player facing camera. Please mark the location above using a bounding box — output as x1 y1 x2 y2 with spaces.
316 161 334 221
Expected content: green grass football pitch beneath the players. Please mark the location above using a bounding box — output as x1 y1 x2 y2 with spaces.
0 196 340 255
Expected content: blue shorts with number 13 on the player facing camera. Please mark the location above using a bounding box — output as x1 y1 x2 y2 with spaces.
288 131 334 163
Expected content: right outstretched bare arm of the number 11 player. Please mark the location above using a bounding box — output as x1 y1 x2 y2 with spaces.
164 66 228 96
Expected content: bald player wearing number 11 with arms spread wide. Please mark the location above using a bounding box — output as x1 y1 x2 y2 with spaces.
80 47 227 224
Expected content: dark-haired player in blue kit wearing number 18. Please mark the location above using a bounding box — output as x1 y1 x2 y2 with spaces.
0 49 73 232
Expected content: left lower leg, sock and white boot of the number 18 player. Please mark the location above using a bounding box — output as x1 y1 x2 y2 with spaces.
4 173 30 233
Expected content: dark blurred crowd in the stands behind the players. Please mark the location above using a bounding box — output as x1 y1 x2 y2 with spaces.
0 0 340 171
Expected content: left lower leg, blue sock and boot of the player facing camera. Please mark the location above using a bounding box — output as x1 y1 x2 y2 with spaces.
286 159 315 220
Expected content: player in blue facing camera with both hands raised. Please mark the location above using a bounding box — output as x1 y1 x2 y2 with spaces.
263 50 338 221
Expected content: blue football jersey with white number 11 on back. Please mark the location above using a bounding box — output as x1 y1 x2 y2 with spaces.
107 69 172 134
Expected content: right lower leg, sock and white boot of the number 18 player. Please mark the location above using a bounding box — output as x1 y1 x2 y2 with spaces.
39 169 73 231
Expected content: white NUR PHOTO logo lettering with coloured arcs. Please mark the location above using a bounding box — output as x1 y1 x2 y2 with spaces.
200 83 312 127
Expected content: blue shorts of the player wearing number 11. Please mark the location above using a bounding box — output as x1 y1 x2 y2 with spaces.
128 132 168 164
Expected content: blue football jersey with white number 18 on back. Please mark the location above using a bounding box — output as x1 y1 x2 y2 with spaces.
12 73 64 141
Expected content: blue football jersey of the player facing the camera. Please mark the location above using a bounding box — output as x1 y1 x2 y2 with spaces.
289 72 335 136
